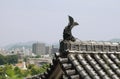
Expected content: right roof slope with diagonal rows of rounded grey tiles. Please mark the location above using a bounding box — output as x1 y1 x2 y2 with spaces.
65 53 120 79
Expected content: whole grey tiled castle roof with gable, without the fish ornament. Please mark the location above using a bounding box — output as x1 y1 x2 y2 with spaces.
27 41 120 79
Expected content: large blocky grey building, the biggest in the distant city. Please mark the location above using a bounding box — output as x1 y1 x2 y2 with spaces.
32 42 46 55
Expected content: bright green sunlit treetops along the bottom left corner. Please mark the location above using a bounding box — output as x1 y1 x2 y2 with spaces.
0 64 49 79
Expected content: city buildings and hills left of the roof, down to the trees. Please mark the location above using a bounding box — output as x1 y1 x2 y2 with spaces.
0 42 59 69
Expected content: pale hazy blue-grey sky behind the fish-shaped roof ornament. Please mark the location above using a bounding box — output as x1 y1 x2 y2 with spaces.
0 0 120 46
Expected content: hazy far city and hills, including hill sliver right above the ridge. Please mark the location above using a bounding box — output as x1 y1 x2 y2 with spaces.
0 39 120 60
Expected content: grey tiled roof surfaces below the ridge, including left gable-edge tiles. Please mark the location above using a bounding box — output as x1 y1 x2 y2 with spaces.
28 53 120 79
